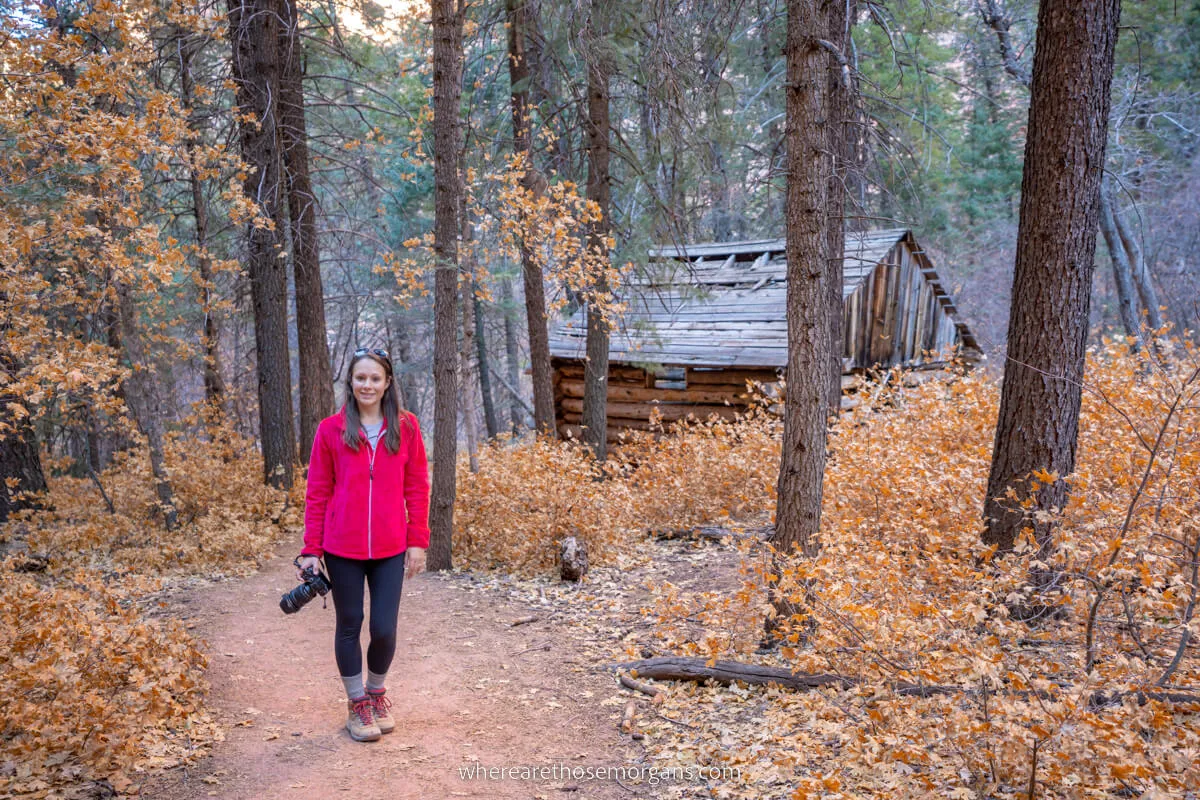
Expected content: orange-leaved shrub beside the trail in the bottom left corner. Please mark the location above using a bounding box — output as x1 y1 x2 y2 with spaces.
0 564 217 793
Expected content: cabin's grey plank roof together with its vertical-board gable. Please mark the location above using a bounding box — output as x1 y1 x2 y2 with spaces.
550 228 978 372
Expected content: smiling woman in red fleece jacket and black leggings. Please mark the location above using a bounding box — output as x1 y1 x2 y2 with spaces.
299 350 430 741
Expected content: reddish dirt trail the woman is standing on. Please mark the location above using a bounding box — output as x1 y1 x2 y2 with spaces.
142 547 643 800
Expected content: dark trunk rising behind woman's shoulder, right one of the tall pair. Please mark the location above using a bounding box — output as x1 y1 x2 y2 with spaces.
278 0 334 463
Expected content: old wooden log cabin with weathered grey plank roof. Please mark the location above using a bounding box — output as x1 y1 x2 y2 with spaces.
550 229 979 439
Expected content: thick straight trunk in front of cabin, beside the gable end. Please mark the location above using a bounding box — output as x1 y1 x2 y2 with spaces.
773 0 833 555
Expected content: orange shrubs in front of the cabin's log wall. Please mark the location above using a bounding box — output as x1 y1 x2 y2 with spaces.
455 417 779 573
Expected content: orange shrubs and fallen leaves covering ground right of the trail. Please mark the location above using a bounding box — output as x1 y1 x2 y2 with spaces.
458 343 1200 798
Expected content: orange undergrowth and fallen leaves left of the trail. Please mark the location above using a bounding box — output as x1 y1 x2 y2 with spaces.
0 419 304 798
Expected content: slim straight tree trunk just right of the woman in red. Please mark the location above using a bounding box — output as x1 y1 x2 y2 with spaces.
428 0 462 570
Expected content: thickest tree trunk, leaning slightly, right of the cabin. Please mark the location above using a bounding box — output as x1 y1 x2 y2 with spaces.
983 0 1121 551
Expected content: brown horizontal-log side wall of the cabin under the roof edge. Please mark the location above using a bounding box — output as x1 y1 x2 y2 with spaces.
552 359 779 441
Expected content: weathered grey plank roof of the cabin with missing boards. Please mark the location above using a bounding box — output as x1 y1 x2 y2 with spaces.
550 228 978 368
